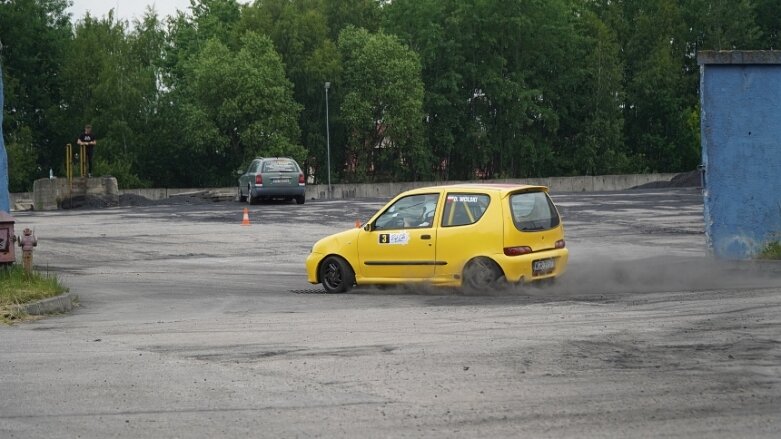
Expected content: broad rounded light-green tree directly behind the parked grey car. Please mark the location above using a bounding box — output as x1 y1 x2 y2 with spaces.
180 32 306 184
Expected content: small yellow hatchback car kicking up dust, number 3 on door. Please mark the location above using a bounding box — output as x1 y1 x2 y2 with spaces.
306 184 568 293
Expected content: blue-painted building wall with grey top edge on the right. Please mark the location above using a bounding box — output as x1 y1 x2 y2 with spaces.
697 51 781 259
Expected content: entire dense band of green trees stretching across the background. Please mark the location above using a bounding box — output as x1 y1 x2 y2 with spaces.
0 0 781 191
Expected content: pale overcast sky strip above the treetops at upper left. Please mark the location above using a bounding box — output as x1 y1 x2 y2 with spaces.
70 0 195 22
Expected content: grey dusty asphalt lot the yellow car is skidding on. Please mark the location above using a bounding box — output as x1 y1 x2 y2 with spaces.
0 189 781 438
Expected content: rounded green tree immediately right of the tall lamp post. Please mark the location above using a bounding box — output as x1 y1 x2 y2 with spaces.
339 27 430 181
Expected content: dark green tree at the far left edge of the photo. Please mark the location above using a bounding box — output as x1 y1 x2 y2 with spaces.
0 0 71 188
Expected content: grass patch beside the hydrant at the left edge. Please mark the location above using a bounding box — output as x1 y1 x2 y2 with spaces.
0 265 68 323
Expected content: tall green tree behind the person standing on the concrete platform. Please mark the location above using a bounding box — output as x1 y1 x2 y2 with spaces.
62 11 162 187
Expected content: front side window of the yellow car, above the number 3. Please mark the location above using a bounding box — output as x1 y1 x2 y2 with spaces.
374 194 439 230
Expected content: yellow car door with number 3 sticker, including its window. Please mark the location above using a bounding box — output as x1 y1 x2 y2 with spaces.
358 193 440 280
